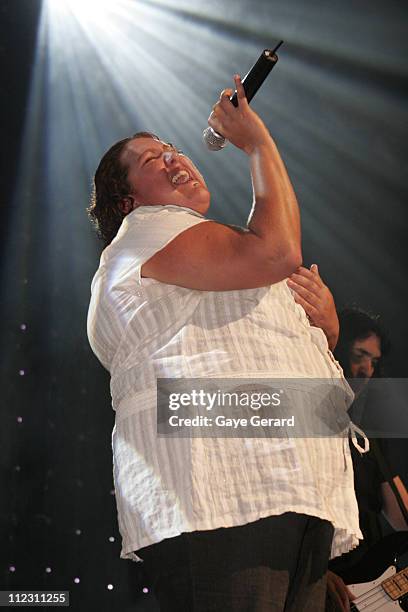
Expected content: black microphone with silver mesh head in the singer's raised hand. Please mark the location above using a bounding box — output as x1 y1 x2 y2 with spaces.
203 40 283 151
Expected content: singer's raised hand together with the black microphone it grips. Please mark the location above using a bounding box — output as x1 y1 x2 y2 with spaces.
203 41 283 151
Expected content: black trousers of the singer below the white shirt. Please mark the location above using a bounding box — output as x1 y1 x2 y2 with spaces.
137 512 333 612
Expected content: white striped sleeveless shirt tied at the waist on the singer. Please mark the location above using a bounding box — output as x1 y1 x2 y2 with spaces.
88 206 362 559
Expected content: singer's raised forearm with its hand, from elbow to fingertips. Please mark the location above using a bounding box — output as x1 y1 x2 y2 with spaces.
208 75 301 268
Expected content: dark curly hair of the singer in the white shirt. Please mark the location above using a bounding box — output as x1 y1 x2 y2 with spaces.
86 132 160 246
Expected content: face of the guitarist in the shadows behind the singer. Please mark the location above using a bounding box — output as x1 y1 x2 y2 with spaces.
350 334 381 392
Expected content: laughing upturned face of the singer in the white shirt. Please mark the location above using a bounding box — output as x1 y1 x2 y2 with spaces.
122 138 210 214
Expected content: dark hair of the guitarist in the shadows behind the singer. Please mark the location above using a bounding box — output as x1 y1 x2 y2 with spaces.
334 307 391 378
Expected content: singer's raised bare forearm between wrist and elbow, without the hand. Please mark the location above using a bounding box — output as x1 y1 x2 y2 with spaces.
248 137 301 265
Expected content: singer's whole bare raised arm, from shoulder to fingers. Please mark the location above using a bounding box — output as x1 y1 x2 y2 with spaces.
142 77 301 291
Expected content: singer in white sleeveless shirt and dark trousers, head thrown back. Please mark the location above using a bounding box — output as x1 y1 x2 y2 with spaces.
88 76 362 612
